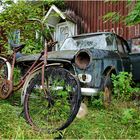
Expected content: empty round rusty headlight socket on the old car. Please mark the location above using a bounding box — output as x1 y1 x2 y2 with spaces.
75 49 92 69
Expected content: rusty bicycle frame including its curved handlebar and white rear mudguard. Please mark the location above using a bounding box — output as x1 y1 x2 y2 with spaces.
2 19 56 98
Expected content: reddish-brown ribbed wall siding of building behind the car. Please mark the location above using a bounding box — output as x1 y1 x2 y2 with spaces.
65 0 140 39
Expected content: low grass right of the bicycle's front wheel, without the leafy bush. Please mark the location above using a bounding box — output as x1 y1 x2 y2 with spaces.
64 101 140 139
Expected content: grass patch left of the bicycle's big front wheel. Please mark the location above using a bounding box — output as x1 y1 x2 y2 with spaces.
0 92 58 139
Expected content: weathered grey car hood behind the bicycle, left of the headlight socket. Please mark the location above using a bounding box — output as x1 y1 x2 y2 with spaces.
16 50 77 62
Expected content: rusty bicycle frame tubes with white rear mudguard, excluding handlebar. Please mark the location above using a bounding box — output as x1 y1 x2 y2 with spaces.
0 41 48 91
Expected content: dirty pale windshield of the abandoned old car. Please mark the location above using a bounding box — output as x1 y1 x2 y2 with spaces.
60 34 113 51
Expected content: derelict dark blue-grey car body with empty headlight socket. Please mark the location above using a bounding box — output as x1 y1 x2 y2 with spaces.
17 32 140 96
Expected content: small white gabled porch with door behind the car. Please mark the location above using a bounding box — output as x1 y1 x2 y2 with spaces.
44 5 77 50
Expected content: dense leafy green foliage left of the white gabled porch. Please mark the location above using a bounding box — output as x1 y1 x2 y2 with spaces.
0 0 64 53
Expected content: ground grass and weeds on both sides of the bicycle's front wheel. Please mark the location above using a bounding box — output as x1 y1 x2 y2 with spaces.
0 72 140 139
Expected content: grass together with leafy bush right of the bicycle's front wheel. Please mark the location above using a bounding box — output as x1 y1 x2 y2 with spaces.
64 72 140 139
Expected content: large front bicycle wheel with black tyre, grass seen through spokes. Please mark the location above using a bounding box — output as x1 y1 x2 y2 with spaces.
24 67 81 133
